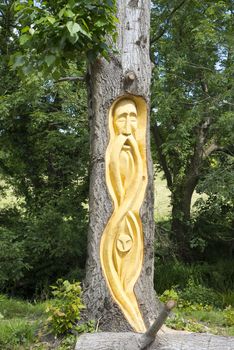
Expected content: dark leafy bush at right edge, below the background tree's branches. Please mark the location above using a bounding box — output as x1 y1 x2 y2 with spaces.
193 155 234 261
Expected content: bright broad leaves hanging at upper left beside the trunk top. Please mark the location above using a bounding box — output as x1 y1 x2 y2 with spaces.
12 0 116 77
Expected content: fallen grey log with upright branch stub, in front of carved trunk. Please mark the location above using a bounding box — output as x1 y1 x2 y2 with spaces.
75 300 234 350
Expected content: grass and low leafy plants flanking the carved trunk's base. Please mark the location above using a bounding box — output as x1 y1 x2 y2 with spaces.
0 278 234 350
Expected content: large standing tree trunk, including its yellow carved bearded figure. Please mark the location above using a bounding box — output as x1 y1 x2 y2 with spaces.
84 0 160 331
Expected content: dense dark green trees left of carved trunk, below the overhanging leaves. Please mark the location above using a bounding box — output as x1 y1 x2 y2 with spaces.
0 1 89 296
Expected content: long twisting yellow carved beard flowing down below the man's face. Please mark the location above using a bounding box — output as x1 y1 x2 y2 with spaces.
100 131 145 331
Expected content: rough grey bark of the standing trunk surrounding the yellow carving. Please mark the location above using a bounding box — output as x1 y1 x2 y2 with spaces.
84 0 160 330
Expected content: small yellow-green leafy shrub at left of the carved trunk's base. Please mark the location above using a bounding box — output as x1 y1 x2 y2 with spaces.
47 279 85 335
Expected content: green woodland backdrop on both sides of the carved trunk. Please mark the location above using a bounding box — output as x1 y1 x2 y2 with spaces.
0 0 234 348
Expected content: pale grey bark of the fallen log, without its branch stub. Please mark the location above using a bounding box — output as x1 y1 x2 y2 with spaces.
76 331 234 350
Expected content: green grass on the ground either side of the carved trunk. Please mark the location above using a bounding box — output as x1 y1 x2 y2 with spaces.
0 295 234 350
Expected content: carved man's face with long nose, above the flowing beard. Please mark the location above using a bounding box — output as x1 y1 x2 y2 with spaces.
114 99 137 136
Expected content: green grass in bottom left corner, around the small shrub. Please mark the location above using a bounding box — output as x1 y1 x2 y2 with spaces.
0 292 95 350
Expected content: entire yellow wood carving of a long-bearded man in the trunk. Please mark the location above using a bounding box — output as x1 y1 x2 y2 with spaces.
100 95 147 332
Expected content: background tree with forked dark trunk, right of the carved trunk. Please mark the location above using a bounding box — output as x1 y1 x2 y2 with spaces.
151 0 233 261
